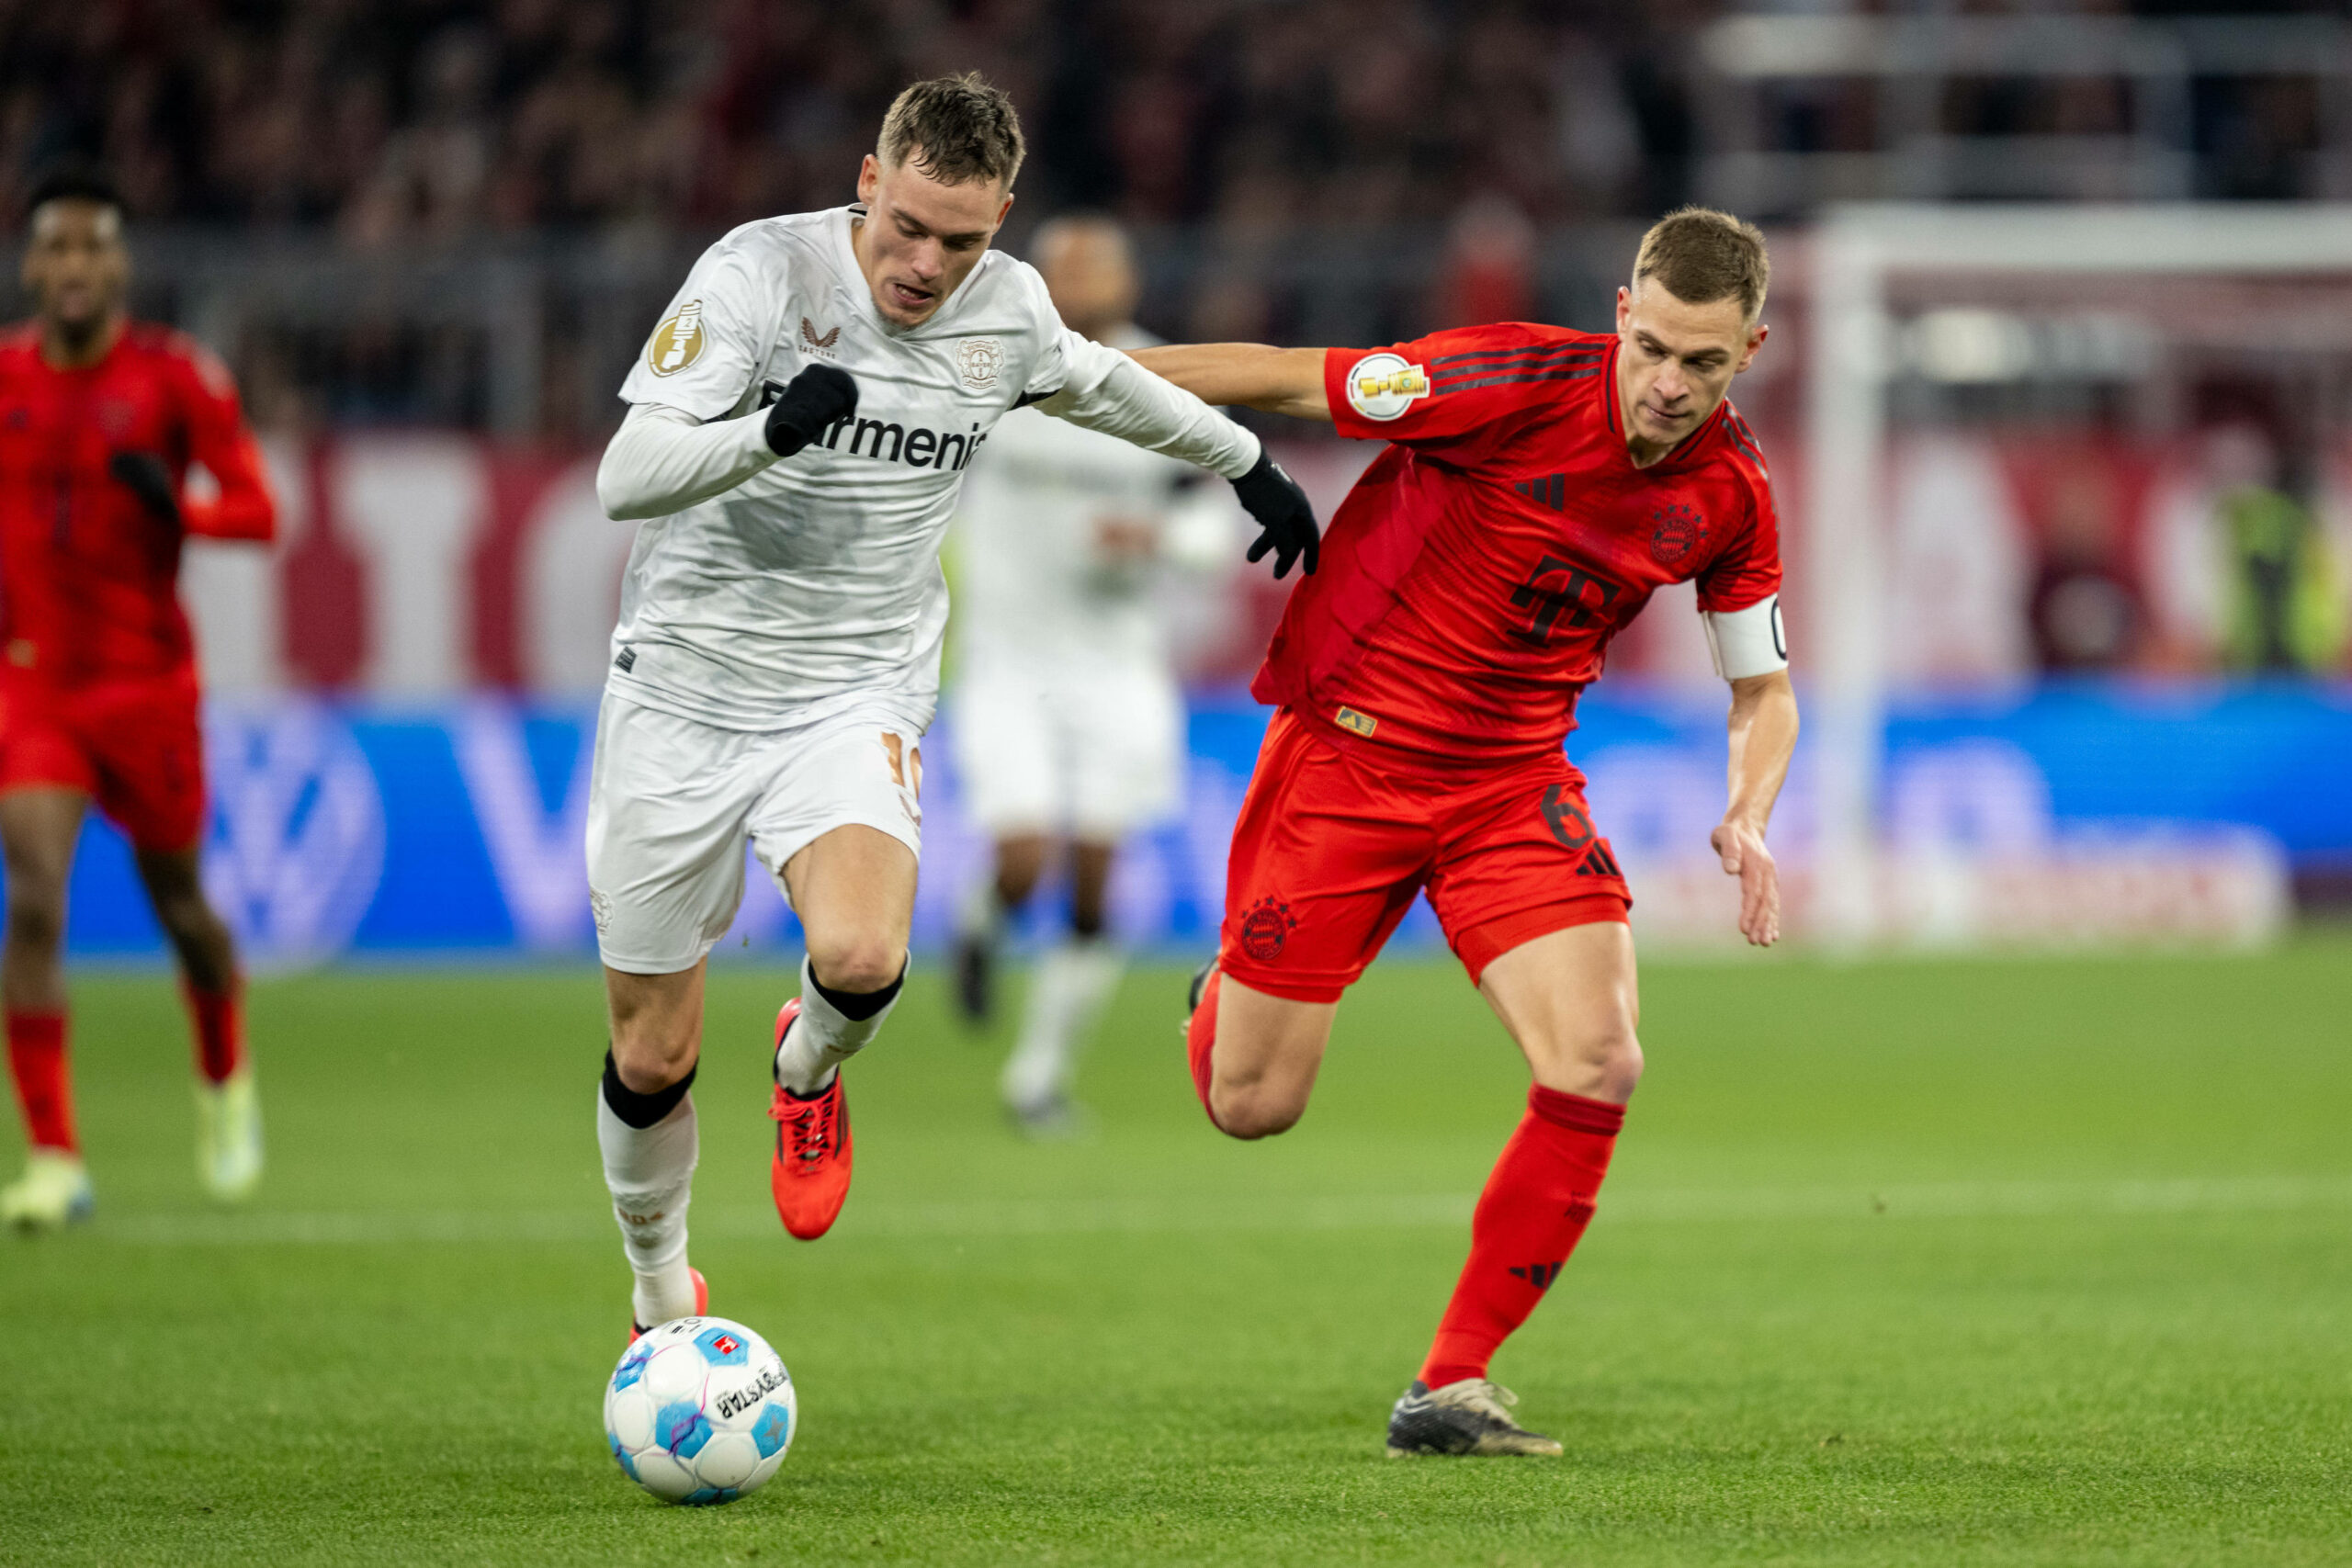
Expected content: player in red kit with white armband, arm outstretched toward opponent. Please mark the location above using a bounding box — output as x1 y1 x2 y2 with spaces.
1136 209 1797 1455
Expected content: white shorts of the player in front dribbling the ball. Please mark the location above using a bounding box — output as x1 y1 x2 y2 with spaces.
588 691 922 976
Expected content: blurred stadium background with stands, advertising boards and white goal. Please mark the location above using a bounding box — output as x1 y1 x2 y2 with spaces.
0 0 2352 966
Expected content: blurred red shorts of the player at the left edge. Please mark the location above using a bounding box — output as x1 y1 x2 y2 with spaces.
0 674 205 851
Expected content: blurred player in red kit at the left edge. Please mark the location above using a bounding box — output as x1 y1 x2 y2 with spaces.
0 174 276 1229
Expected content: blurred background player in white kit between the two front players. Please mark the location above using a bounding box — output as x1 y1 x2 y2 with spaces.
955 216 1239 1135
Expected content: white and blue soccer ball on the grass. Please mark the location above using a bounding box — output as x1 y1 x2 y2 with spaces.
605 1316 799 1502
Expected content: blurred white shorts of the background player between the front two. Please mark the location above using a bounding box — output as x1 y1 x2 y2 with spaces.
955 665 1185 841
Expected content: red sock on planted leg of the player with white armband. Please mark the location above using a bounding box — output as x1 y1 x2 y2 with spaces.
1420 1084 1625 1389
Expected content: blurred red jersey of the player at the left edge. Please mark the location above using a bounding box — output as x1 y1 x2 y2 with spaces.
0 322 277 686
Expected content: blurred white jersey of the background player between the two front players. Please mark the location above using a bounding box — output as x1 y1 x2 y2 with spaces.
955 332 1239 668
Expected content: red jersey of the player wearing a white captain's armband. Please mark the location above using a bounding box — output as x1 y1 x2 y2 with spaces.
1251 322 1781 764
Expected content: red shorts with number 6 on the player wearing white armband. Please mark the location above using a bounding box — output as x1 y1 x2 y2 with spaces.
1216 707 1633 1001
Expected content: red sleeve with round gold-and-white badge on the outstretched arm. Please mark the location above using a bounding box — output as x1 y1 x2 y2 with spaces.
1324 322 1609 463
